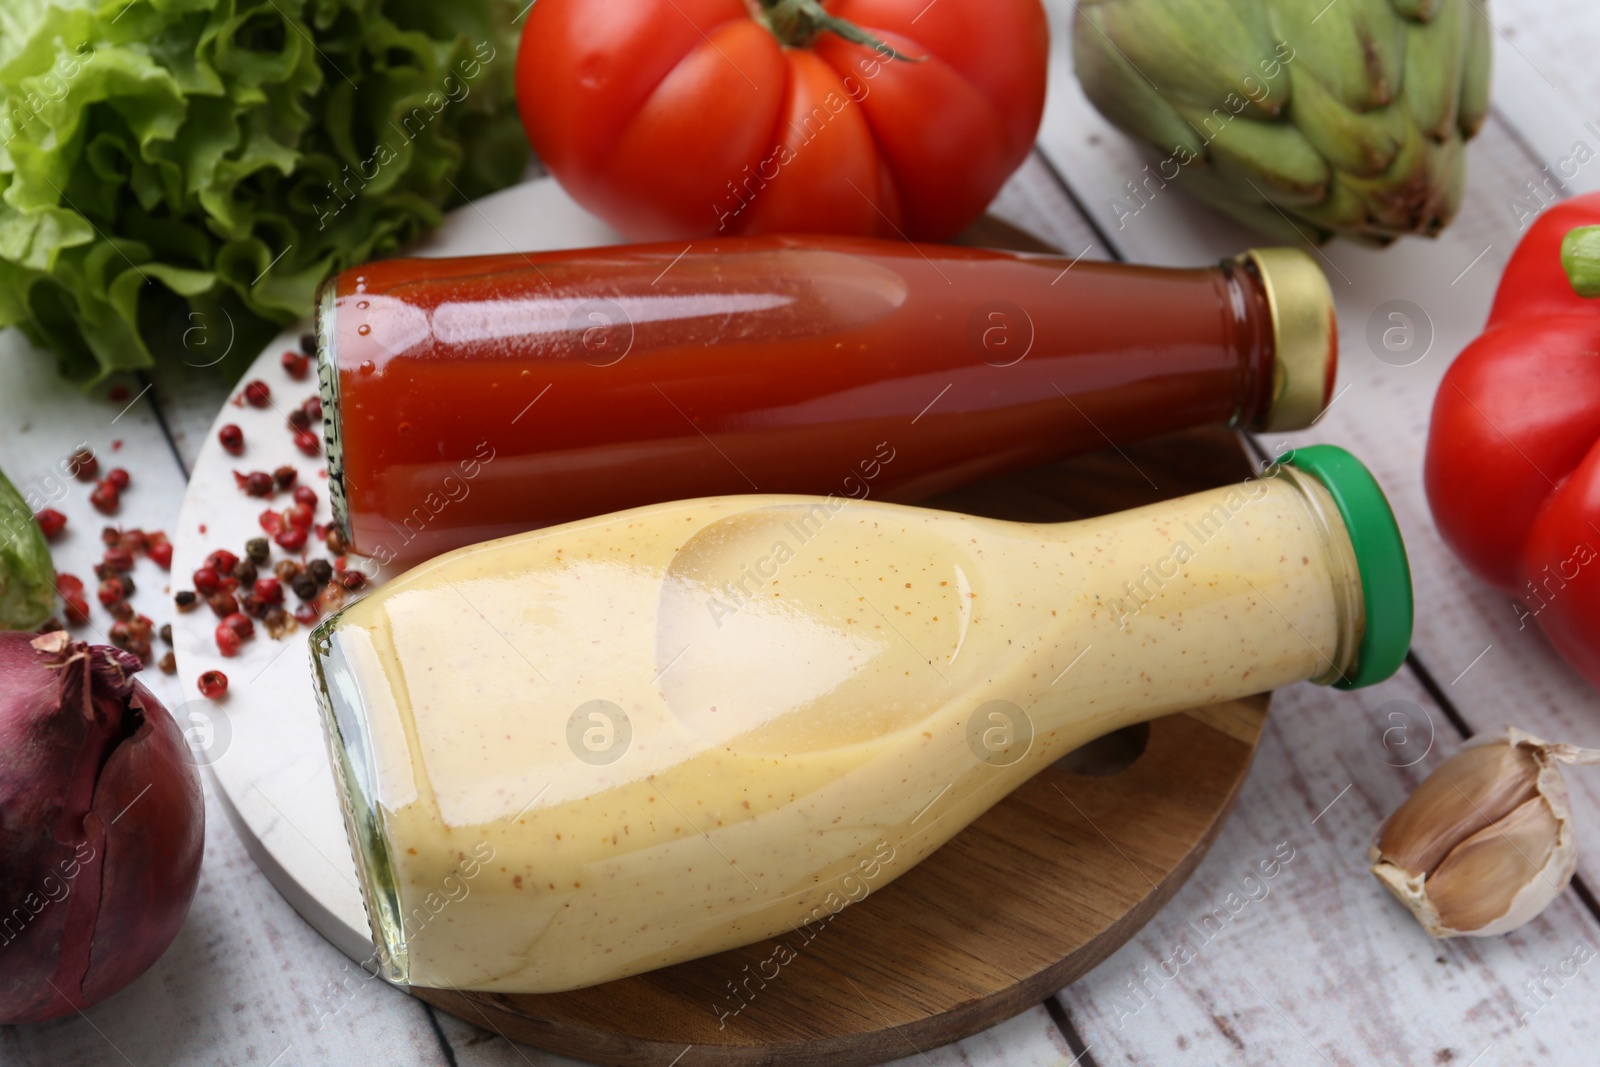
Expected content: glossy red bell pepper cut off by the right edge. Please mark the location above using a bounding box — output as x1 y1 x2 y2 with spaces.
1426 194 1600 686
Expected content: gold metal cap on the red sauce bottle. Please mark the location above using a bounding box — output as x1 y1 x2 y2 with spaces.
1237 248 1339 430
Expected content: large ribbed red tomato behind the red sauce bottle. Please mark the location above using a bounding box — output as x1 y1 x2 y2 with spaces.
517 0 1050 240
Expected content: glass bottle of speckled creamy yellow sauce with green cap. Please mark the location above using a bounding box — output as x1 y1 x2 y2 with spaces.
312 446 1411 992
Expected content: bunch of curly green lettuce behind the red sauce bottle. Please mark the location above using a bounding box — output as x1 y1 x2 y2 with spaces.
0 0 528 381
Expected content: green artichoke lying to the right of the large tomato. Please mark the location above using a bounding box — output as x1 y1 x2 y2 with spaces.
1072 0 1491 245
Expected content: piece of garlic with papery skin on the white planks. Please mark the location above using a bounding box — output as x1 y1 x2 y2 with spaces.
1366 726 1600 937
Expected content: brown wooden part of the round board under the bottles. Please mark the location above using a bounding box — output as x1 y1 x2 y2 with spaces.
413 429 1269 1067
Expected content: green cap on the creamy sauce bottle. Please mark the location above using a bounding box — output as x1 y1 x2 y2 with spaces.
1278 445 1416 689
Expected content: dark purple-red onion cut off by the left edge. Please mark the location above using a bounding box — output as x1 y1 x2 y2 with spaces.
0 632 205 1024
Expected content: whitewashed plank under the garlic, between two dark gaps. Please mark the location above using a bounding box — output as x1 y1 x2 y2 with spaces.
1061 675 1600 1067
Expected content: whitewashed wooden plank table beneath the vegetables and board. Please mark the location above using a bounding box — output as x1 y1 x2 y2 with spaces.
0 0 1600 1067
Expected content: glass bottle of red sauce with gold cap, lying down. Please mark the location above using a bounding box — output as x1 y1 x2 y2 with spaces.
317 235 1338 563
